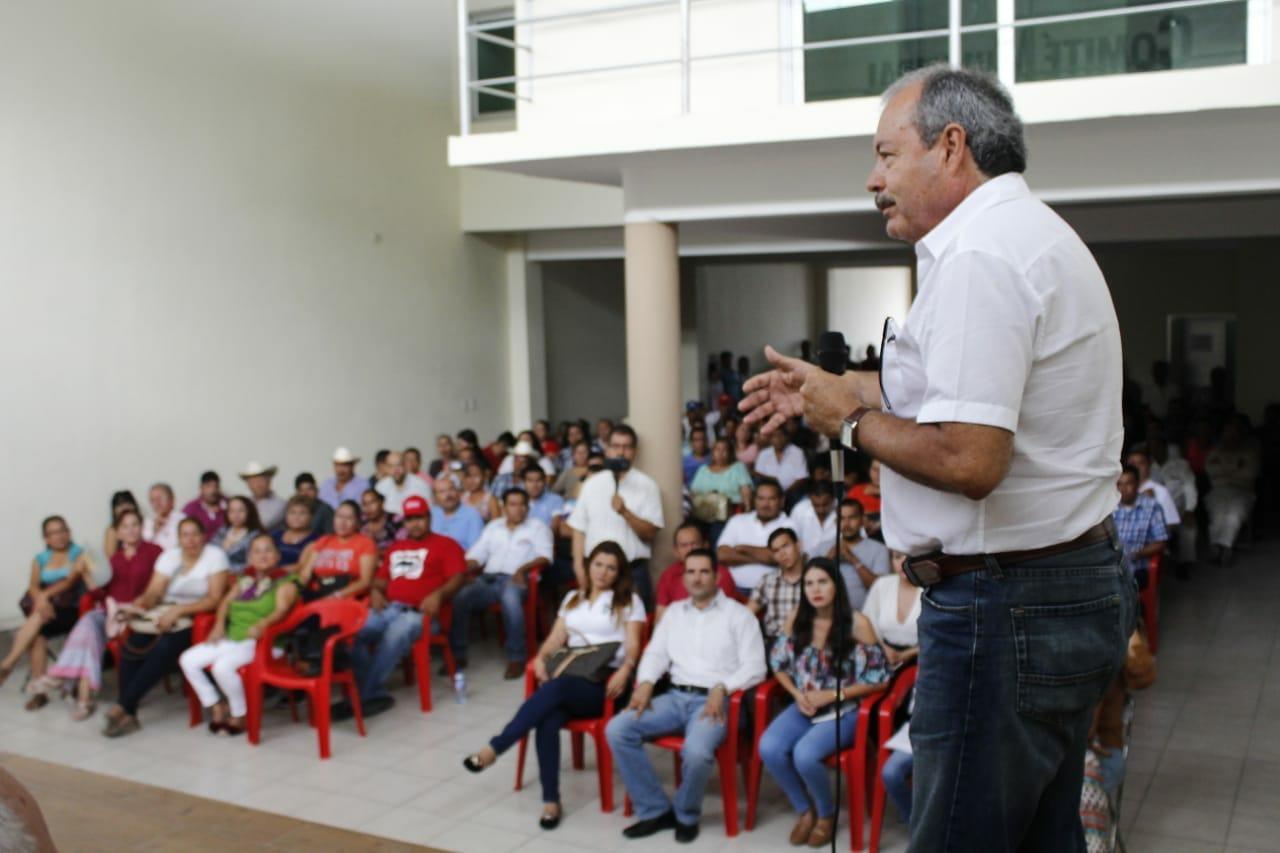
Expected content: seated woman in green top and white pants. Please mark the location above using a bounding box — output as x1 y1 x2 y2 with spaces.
178 535 300 735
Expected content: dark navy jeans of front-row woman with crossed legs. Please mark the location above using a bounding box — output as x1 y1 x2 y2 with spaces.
489 676 604 803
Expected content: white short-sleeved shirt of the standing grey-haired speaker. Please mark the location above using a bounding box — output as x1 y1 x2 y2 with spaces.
881 174 1124 555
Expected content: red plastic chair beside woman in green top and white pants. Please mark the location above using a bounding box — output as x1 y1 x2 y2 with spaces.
241 598 367 758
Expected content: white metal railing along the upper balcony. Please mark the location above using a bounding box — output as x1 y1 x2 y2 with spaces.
457 0 1272 136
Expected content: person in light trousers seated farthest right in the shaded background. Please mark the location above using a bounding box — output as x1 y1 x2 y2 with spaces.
1204 415 1261 565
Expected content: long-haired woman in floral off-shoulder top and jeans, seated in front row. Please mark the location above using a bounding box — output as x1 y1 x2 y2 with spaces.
760 558 888 847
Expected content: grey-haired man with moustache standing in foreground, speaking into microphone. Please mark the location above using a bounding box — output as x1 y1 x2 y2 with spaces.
741 67 1137 853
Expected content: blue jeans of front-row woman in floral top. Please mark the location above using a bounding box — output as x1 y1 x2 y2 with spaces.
760 704 858 817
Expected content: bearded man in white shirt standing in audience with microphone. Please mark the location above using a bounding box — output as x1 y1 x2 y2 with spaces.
568 424 663 608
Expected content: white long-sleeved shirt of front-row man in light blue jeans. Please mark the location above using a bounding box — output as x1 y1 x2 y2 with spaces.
636 590 768 693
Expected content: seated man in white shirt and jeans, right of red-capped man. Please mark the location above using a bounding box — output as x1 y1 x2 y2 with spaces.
449 489 552 679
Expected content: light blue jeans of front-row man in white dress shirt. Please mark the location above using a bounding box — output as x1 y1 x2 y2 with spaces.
604 690 728 824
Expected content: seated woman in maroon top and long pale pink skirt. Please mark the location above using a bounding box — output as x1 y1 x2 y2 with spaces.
46 510 163 721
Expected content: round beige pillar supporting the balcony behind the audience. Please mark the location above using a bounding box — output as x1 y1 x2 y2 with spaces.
626 222 684 579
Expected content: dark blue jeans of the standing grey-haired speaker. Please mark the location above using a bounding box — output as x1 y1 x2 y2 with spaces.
909 542 1137 853
